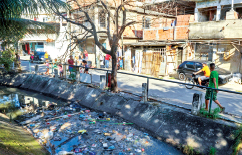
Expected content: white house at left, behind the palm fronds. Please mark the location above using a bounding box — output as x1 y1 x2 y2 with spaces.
19 12 69 59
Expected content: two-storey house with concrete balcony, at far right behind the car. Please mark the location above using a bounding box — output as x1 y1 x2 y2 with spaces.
189 0 242 73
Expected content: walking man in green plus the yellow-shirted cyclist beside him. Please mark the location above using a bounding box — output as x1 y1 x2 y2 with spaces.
194 63 225 111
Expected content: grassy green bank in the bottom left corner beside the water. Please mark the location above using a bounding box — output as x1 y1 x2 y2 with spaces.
0 114 49 155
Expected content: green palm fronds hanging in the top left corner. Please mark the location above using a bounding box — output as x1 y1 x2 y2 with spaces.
0 0 69 42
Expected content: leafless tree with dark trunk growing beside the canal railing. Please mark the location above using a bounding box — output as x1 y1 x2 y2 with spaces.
54 0 136 92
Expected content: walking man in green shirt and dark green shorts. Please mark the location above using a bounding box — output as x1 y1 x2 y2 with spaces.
205 63 225 111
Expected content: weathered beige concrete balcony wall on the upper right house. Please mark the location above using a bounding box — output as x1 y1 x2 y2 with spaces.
189 19 242 39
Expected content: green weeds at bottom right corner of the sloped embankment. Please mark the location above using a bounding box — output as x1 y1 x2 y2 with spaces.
233 125 242 155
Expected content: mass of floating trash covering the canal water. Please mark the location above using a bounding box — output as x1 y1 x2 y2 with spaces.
21 103 158 155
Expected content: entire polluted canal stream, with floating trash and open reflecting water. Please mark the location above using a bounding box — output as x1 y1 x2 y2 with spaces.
0 86 182 155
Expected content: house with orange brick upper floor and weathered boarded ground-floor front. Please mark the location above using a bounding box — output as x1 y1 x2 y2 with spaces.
125 0 195 77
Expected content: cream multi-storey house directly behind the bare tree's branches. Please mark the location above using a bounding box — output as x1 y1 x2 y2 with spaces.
71 0 152 67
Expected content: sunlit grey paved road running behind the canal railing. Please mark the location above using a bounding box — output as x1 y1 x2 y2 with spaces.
22 61 242 116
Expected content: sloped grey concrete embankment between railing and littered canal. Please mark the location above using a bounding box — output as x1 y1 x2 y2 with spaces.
0 74 237 155
